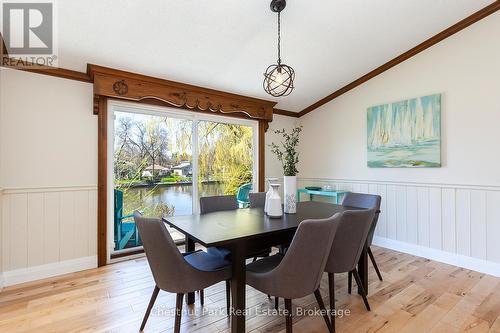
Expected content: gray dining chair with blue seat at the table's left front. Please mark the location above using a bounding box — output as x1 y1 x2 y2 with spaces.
134 213 231 333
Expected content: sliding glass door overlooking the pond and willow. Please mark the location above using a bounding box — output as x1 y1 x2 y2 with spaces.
108 102 258 254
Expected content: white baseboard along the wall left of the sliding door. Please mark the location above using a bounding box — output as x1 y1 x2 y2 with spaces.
0 256 97 287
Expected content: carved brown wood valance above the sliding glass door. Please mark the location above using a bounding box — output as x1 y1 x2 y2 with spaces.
88 65 276 121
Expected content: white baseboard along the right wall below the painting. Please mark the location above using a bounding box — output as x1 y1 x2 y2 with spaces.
373 236 500 277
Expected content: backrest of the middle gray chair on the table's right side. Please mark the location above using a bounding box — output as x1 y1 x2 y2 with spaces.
325 209 375 273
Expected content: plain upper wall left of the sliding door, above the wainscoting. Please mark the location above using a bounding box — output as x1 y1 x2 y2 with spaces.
0 69 97 188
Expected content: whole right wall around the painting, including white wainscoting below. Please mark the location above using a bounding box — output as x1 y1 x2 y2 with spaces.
300 13 500 275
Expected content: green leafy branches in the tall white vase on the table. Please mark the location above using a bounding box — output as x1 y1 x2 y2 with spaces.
269 126 302 176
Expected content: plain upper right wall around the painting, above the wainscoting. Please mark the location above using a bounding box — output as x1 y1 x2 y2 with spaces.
301 13 500 185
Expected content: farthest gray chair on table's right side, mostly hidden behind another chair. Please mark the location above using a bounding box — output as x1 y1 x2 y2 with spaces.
342 193 382 294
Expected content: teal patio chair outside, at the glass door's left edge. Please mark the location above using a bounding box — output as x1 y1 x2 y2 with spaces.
114 189 140 250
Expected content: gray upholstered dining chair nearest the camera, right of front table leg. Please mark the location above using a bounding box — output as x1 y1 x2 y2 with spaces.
246 214 342 333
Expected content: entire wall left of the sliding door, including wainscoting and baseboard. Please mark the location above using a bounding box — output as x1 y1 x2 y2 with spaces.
0 68 97 284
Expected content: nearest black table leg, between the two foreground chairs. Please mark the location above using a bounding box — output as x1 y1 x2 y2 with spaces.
230 244 246 333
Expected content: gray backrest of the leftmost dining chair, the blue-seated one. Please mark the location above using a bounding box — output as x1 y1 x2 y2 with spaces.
134 212 194 293
